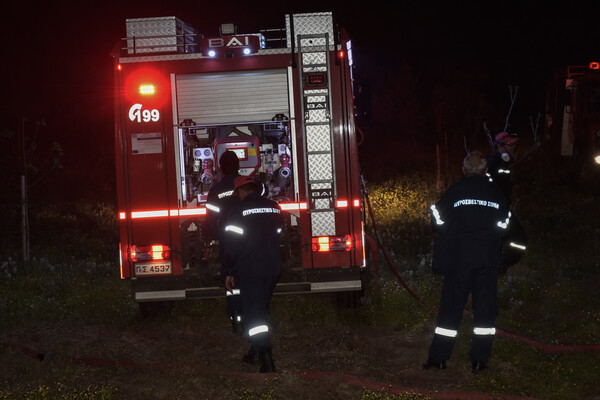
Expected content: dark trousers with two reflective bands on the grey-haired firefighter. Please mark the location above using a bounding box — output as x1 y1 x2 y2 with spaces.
429 265 498 364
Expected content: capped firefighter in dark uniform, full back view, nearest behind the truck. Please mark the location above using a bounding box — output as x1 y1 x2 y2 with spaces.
225 176 282 372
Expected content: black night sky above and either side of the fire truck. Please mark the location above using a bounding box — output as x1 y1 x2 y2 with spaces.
0 0 600 198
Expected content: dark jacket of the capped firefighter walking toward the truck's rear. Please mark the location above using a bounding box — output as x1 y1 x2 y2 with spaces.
223 192 283 280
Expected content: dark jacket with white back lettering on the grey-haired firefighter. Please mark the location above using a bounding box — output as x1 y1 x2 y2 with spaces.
431 175 510 274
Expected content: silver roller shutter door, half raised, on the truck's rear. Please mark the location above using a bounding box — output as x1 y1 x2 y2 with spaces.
176 69 289 126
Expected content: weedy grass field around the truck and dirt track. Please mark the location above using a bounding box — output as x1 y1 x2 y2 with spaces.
0 163 600 400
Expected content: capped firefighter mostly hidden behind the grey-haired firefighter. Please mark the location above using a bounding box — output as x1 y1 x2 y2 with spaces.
487 132 528 272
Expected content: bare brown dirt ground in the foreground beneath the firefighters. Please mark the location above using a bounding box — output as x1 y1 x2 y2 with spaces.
0 296 536 399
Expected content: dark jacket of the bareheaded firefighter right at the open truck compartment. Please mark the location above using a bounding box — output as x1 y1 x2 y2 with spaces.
204 173 240 240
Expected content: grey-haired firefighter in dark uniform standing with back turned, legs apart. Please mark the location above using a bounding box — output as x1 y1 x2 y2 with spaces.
423 152 510 373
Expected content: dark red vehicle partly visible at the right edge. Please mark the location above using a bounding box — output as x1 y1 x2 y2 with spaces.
547 62 600 171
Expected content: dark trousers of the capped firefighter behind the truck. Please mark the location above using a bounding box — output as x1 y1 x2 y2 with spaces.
240 276 279 352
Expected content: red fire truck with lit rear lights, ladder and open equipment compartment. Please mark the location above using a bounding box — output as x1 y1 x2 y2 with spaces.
114 12 365 308
